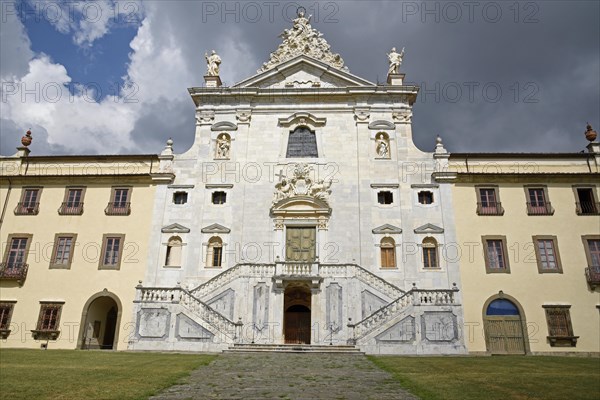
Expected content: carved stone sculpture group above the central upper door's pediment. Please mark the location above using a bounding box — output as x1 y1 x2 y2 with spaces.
273 163 332 208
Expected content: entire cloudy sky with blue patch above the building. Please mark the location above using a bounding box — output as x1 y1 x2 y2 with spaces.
0 0 600 155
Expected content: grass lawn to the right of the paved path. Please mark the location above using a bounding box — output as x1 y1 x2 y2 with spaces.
369 356 600 400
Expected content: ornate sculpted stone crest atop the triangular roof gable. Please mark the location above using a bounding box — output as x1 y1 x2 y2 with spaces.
258 7 348 73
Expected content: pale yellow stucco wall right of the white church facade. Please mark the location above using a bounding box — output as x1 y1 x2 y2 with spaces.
453 178 600 353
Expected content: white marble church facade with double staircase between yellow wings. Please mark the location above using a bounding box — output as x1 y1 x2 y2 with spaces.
130 14 465 354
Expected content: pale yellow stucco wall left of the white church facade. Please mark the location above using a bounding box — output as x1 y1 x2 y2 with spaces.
0 156 162 350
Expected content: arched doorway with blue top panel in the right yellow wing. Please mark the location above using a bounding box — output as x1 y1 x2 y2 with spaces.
483 295 529 354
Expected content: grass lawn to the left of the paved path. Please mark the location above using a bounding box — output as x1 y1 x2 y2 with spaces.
0 349 216 400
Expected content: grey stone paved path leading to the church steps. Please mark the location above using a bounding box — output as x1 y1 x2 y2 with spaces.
151 353 416 400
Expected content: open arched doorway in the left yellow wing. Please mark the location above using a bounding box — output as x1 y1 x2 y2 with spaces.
77 291 122 350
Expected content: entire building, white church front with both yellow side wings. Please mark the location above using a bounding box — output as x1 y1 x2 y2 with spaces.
0 10 600 356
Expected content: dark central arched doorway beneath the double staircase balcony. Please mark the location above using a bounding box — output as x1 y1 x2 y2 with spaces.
283 284 311 344
